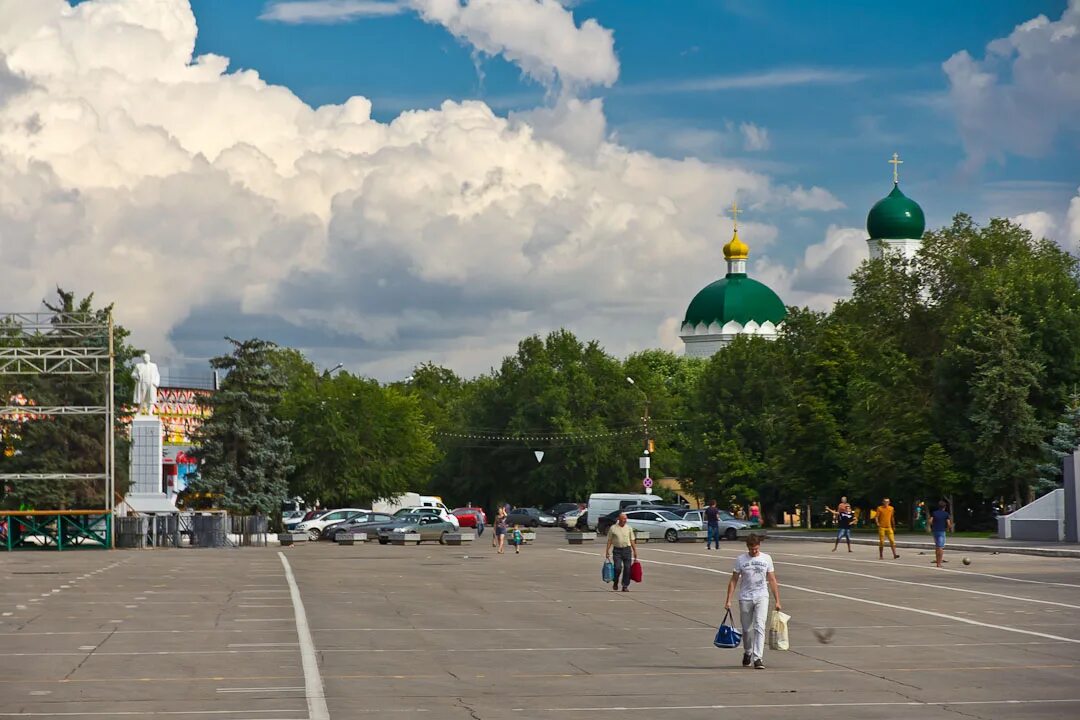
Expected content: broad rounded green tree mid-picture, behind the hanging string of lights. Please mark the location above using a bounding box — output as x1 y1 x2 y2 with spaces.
436 330 643 505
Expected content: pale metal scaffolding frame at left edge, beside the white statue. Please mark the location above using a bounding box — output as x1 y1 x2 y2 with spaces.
0 312 116 547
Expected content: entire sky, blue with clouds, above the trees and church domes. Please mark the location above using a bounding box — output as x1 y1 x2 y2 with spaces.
0 0 1080 381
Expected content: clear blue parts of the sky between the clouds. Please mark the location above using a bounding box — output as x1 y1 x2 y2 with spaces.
192 0 1080 249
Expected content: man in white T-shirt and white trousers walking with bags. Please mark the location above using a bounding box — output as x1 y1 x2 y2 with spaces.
724 533 780 670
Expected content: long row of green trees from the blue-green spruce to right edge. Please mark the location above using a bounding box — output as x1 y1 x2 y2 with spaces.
0 215 1080 527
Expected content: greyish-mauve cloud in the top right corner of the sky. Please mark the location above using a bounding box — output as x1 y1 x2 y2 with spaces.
943 0 1080 167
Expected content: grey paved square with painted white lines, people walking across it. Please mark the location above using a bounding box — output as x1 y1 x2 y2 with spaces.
0 530 1080 720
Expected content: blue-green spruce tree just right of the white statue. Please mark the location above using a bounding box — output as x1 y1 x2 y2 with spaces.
189 338 293 514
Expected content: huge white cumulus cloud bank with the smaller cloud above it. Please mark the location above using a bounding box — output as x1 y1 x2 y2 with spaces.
0 0 851 378
